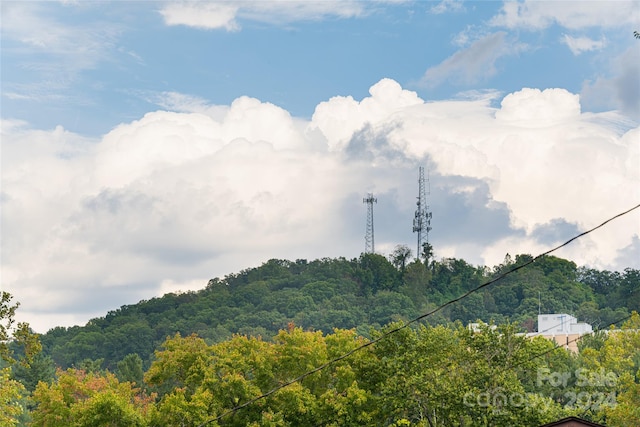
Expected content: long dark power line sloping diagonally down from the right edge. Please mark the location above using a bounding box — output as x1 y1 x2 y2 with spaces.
198 204 640 427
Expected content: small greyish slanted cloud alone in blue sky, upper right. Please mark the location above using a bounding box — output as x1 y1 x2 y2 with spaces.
420 32 523 87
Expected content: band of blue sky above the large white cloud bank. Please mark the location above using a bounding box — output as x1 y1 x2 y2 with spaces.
2 1 638 135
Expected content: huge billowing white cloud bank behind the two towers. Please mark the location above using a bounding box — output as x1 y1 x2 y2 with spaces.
0 79 640 331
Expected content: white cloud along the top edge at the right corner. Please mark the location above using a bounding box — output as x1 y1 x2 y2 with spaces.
490 0 639 30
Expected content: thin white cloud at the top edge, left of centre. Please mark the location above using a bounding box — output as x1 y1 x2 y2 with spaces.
160 0 370 31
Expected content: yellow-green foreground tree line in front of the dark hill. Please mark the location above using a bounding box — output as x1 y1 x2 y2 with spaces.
0 290 640 427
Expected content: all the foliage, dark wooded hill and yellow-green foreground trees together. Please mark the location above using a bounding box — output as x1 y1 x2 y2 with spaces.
0 252 640 427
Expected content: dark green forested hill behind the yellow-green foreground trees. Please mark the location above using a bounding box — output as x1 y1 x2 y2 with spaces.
41 254 640 369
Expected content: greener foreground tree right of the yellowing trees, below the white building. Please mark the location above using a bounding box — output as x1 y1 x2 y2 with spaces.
367 325 562 426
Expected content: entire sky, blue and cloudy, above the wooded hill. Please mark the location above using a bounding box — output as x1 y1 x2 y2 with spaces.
0 0 640 332
